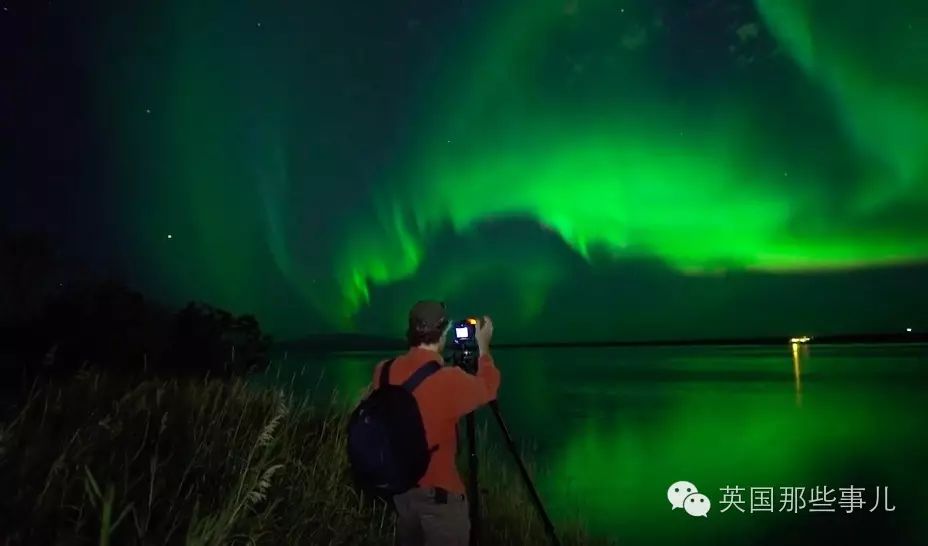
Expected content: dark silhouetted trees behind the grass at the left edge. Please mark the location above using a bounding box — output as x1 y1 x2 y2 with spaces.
0 233 270 396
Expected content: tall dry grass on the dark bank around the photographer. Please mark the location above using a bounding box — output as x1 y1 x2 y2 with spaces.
0 371 608 546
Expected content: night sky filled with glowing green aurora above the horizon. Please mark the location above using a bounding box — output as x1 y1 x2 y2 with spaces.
0 0 928 341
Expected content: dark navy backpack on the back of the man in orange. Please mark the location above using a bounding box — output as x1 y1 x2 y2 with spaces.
348 360 441 496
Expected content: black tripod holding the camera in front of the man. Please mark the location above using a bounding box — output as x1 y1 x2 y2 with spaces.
452 347 561 546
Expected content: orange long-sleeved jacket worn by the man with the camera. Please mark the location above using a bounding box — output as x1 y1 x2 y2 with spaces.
373 347 500 494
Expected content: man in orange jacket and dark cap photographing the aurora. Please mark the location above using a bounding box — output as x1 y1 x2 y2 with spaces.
373 301 500 546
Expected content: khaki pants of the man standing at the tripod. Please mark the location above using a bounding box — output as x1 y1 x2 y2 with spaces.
393 487 470 546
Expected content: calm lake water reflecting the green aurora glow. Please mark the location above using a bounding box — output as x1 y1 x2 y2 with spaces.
258 345 928 545
